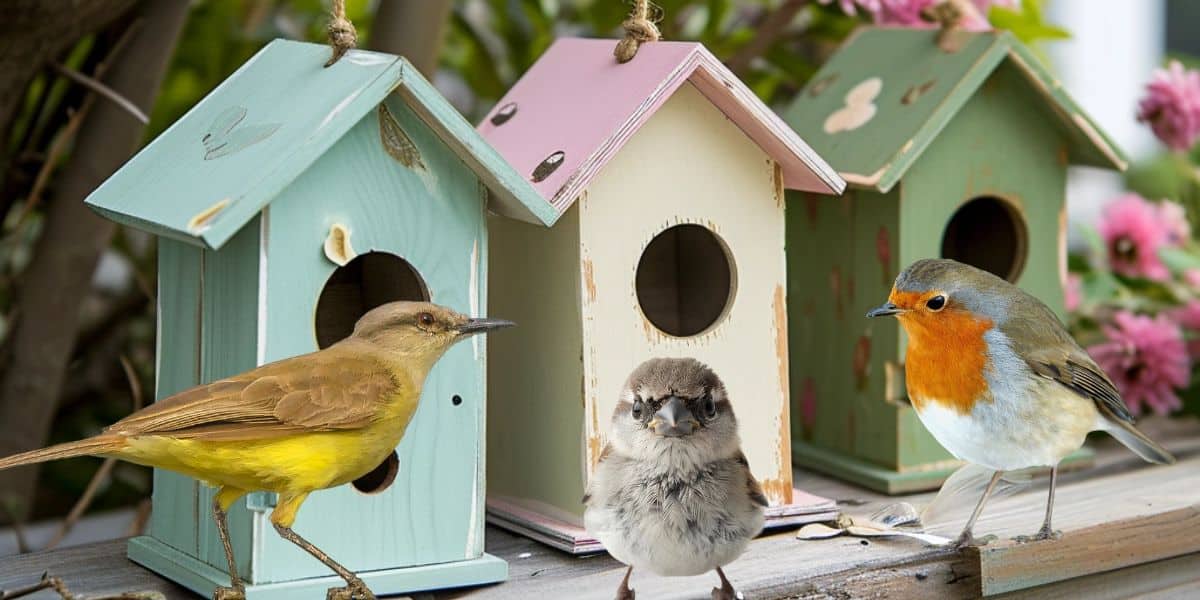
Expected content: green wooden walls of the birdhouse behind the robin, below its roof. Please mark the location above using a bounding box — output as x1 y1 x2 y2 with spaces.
787 65 1067 492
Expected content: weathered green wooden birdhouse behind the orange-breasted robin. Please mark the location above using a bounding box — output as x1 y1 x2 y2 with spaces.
784 28 1126 493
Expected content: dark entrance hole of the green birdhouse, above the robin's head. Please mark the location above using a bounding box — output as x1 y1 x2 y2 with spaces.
942 196 1028 282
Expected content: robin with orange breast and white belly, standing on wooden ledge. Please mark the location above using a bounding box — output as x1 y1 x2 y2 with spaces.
866 259 1175 547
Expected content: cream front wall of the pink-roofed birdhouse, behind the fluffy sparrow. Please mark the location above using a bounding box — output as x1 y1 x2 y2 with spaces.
577 84 792 504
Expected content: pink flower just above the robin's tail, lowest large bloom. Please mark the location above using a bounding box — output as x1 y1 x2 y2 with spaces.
1087 311 1192 414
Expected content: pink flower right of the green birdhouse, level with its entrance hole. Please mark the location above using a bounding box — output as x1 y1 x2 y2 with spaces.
1099 193 1171 281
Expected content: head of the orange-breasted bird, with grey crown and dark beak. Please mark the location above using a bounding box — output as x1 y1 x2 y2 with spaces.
866 258 1025 323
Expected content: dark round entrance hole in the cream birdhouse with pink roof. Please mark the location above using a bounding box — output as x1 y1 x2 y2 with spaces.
635 224 736 337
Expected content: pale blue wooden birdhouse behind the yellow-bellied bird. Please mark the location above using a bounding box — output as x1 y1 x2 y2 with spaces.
88 41 557 599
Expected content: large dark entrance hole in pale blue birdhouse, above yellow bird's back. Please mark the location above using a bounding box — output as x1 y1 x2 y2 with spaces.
316 252 430 348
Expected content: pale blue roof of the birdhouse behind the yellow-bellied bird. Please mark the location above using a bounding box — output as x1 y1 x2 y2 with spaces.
86 40 557 248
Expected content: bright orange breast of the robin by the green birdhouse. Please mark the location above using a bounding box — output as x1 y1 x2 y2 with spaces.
900 308 992 414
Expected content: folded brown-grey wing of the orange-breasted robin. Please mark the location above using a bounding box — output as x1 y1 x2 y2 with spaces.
1001 295 1133 422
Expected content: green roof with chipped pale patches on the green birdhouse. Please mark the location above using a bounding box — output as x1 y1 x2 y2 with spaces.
784 28 1127 192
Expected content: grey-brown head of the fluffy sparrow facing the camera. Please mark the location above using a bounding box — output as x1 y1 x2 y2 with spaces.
612 359 739 461
